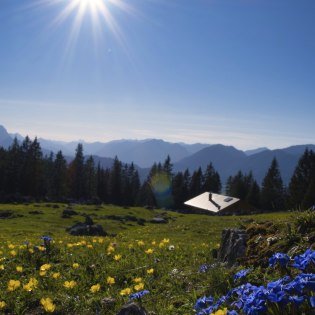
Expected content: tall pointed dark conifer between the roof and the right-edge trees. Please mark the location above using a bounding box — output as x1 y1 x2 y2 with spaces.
261 158 284 211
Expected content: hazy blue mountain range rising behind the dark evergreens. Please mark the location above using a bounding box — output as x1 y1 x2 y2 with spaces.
0 125 315 184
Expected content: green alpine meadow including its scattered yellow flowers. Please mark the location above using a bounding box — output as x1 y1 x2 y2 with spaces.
0 203 292 315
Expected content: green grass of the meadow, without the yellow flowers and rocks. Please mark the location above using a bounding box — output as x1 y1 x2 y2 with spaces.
0 204 290 315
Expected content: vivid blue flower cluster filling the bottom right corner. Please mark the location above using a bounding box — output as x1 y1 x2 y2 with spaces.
195 249 315 315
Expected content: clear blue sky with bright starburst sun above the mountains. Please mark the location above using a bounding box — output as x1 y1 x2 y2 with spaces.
0 0 315 149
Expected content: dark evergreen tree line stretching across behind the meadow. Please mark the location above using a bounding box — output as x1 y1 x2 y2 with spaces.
0 137 315 211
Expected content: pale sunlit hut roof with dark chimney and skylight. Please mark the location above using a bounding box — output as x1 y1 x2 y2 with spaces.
184 192 239 212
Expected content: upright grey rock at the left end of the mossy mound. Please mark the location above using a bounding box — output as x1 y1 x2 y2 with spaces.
218 229 248 267
